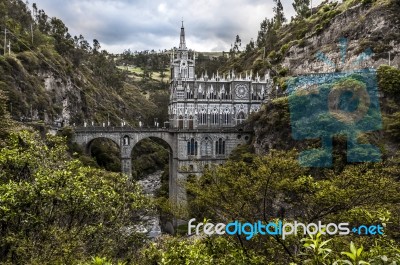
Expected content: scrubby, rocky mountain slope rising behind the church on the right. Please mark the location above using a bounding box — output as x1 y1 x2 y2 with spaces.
220 0 400 80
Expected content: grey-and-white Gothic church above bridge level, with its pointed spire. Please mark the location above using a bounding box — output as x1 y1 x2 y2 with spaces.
168 24 271 130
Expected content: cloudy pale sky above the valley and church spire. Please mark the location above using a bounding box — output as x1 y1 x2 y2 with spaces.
31 0 322 53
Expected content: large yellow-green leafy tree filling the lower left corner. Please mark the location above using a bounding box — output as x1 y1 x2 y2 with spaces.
0 131 148 264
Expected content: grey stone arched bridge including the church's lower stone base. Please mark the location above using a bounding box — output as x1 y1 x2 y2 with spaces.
74 127 252 204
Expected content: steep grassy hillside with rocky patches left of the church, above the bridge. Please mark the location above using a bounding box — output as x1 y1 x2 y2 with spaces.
0 0 166 126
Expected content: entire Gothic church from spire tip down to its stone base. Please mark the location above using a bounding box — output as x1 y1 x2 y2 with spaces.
168 24 272 202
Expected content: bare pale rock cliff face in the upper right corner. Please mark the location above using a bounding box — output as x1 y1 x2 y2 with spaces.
282 1 400 75
